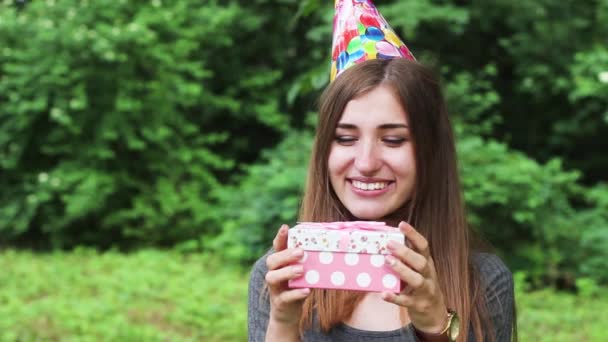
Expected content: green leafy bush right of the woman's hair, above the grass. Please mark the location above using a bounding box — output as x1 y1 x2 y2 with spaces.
458 132 608 286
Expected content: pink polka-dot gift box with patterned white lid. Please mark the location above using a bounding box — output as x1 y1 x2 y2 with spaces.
287 221 405 292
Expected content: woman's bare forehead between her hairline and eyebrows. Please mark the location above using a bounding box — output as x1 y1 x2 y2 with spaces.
339 85 407 127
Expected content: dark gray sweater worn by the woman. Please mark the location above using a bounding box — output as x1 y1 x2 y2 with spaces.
248 253 515 342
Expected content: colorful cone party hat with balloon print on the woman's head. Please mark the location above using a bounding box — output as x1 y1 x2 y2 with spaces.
330 0 415 81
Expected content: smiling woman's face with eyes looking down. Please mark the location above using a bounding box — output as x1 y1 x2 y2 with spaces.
328 85 416 220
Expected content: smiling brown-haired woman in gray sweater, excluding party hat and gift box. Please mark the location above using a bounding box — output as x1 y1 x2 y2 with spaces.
249 58 514 341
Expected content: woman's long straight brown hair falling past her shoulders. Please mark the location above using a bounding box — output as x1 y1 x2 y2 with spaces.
299 59 493 341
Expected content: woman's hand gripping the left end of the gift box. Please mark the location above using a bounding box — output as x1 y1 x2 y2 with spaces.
266 224 310 331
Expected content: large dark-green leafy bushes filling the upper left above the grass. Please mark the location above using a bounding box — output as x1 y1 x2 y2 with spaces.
0 1 302 247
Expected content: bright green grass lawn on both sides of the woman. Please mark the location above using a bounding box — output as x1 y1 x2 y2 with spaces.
0 250 608 342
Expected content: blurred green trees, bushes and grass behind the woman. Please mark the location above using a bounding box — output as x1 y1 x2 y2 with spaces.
0 0 608 341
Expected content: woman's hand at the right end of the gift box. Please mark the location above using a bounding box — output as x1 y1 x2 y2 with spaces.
382 222 448 334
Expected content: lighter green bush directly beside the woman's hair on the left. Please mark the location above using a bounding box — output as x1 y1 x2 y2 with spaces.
206 131 313 262
